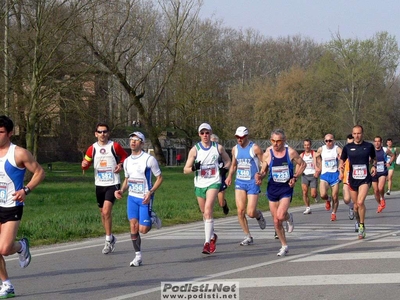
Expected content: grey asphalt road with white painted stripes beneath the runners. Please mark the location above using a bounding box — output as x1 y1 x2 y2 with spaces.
6 192 400 300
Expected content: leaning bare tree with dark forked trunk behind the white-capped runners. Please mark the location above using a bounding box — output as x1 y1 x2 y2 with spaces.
82 0 201 164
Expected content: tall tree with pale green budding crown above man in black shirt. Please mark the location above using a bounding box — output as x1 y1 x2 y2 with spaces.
319 32 400 125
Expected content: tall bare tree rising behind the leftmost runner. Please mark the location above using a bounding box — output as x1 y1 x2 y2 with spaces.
0 0 91 156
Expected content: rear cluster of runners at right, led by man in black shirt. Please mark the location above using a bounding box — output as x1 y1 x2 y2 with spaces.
301 126 397 238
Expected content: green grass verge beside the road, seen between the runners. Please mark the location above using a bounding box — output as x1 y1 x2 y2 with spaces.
18 163 400 245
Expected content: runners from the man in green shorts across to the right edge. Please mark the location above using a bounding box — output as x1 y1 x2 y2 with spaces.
184 123 396 256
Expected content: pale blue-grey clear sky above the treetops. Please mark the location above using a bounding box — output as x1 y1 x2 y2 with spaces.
200 0 400 43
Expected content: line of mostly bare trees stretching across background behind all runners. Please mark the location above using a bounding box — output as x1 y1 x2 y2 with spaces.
0 0 400 163
